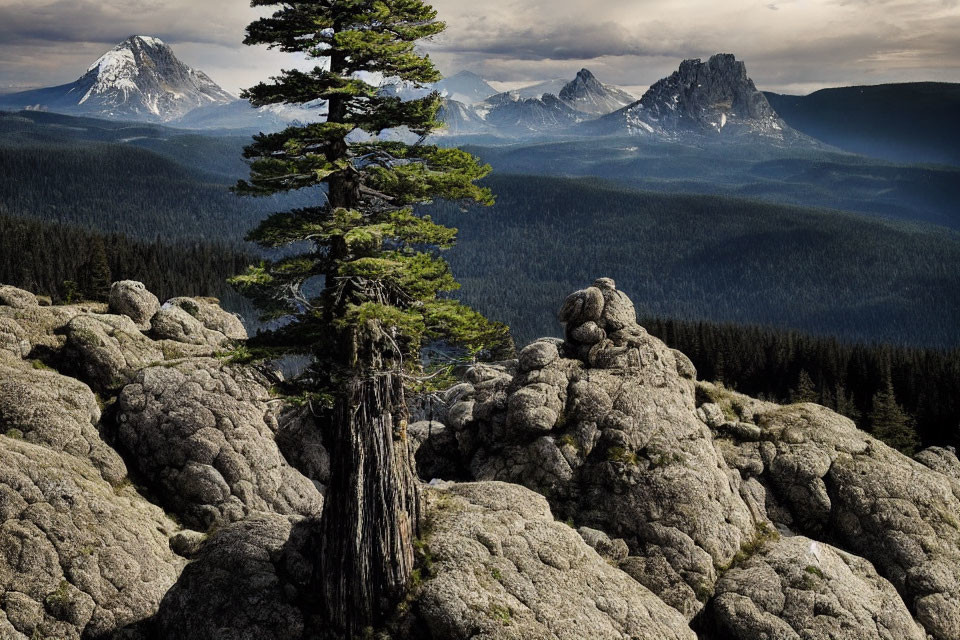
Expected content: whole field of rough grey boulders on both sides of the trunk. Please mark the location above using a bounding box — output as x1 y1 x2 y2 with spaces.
0 278 960 640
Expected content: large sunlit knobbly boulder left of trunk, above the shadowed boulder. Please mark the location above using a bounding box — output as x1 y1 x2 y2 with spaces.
116 358 322 530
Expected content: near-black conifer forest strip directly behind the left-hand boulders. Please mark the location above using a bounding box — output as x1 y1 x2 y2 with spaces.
0 211 251 311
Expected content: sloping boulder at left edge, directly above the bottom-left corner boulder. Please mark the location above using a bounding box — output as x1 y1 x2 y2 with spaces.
0 353 127 485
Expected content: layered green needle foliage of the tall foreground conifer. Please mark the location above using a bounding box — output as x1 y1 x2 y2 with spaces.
233 0 512 380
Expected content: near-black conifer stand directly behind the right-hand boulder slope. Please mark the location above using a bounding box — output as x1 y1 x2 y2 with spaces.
640 318 960 453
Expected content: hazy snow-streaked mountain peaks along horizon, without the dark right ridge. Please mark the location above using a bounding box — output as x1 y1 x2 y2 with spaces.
0 36 788 144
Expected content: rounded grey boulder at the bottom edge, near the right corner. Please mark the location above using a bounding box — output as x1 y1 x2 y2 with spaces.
710 537 926 640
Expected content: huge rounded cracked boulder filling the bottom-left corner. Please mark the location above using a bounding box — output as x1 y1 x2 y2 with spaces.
0 436 183 640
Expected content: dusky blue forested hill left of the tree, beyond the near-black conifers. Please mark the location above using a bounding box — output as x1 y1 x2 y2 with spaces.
0 140 316 244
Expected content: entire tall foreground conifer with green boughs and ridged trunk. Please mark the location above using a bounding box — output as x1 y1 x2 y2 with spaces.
233 0 512 637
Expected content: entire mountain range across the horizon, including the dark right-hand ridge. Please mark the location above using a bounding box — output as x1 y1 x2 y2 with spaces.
0 36 960 164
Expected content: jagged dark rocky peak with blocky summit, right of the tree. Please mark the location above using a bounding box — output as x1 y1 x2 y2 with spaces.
597 53 800 140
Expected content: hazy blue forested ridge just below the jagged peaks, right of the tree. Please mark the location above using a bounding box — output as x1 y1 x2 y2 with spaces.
471 137 960 230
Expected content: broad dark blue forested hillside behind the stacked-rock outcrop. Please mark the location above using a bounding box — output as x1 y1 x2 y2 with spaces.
433 175 960 347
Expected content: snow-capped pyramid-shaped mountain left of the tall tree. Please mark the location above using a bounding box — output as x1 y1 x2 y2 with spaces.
0 36 237 122
